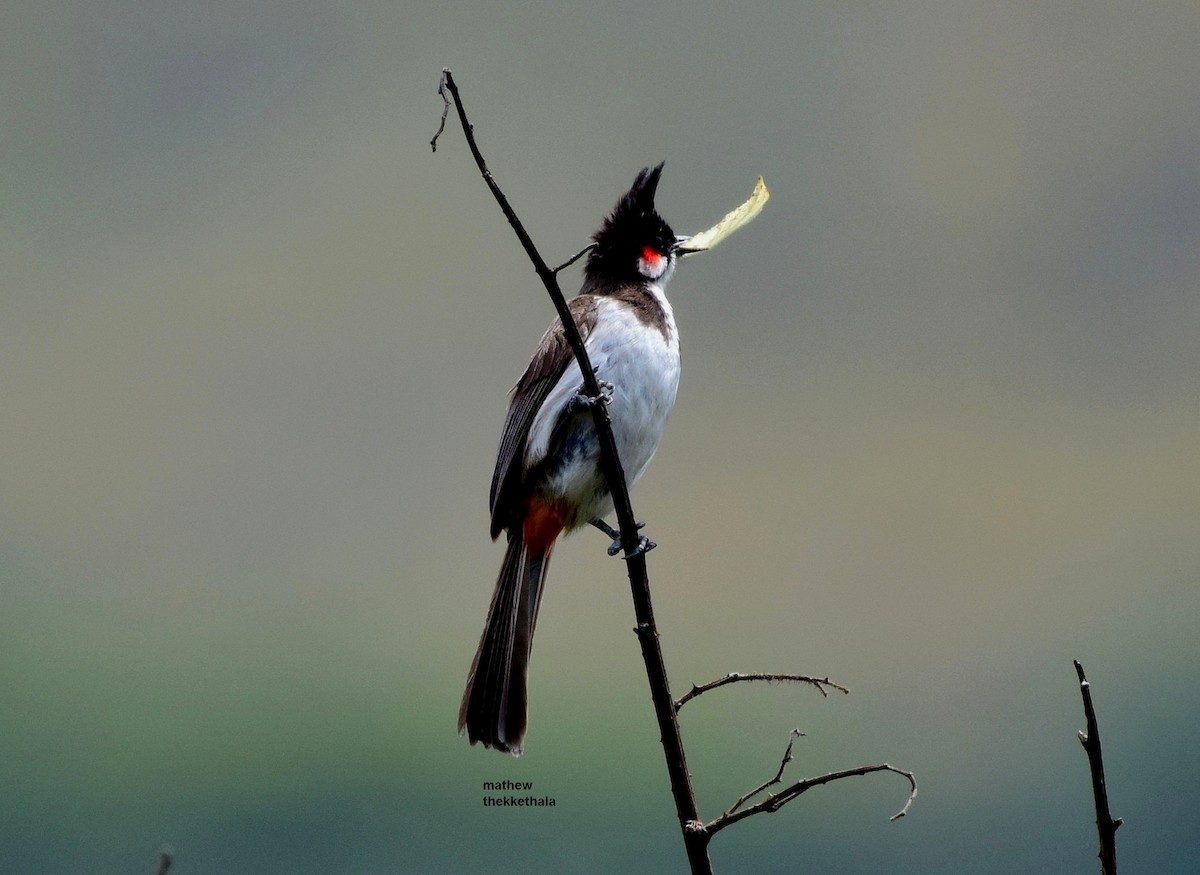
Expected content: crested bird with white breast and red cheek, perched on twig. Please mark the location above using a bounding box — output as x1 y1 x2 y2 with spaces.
458 163 686 756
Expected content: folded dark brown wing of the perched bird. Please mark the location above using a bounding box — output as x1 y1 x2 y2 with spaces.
488 294 596 540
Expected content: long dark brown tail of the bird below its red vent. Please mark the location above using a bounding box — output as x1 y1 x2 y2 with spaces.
458 526 554 756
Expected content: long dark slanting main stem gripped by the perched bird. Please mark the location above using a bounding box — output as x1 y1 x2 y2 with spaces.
431 67 713 875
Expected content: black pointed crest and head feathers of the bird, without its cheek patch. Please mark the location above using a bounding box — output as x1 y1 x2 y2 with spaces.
587 163 674 283
